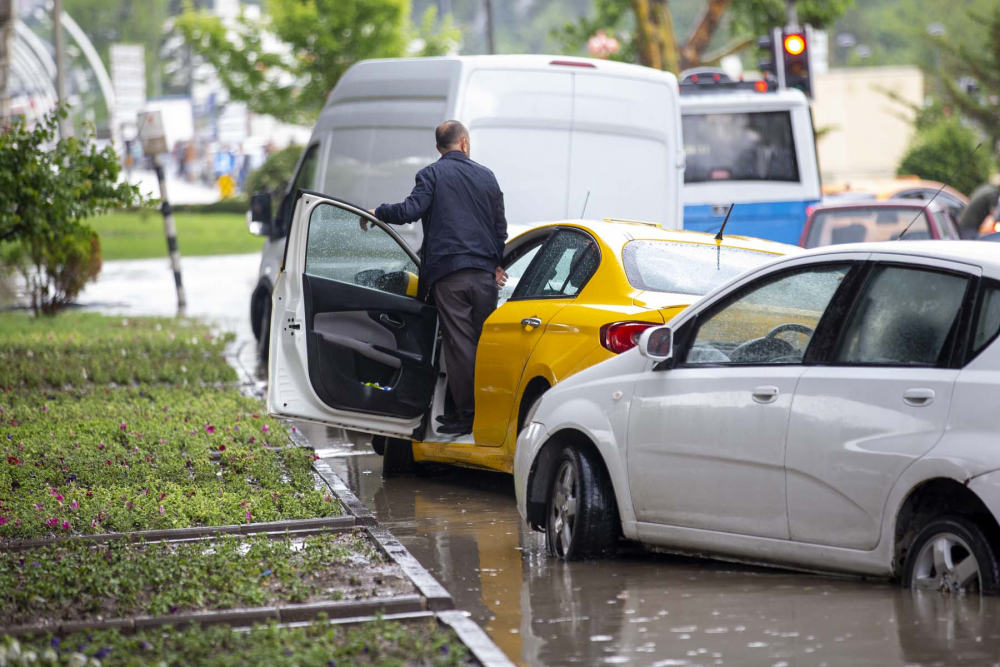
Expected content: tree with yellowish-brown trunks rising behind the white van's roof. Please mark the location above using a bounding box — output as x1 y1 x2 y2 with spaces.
556 0 854 73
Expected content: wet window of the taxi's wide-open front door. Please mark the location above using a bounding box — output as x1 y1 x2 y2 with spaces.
305 204 417 295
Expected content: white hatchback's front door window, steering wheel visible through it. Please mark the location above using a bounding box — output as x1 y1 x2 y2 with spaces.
683 264 850 365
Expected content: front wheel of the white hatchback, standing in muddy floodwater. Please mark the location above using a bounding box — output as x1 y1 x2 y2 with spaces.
545 446 619 560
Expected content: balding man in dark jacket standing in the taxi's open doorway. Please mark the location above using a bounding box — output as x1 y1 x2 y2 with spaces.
361 120 507 436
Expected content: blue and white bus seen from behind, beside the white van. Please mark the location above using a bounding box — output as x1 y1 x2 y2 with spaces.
681 75 820 244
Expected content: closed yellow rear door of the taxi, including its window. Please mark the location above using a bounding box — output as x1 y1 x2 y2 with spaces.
472 228 599 447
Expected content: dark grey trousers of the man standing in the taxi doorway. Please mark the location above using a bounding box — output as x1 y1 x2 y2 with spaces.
431 269 499 416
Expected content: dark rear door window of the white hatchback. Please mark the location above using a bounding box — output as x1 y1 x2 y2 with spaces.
834 266 968 366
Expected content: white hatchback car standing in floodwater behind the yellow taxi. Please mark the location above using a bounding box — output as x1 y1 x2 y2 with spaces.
514 241 1000 593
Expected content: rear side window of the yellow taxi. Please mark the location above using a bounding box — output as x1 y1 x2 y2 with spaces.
511 231 600 299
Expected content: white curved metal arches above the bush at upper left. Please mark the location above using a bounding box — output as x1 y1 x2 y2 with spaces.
14 12 119 144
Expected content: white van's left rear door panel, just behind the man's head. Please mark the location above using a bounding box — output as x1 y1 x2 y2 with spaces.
460 69 582 224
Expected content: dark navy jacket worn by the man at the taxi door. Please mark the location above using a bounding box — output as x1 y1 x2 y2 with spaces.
375 151 507 295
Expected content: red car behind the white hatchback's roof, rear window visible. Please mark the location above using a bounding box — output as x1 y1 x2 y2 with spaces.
799 199 960 248
